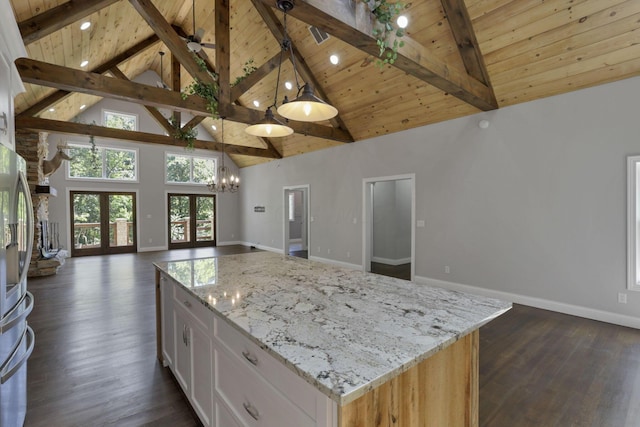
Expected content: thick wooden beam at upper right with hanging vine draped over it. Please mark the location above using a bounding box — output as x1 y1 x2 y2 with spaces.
252 0 498 111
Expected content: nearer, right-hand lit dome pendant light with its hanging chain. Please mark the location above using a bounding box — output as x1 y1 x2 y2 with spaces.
276 0 338 122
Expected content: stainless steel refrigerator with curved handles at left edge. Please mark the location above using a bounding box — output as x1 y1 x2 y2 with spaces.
0 145 34 427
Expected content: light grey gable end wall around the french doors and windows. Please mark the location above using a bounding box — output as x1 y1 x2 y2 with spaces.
48 72 240 251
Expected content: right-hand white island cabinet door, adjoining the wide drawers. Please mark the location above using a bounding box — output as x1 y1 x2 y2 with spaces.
189 324 213 426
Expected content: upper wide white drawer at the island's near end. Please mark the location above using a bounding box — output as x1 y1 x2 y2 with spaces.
215 320 324 418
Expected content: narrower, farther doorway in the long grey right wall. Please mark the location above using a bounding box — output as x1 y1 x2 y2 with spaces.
283 185 309 258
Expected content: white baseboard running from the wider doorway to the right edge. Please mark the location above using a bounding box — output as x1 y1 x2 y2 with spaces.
414 276 640 329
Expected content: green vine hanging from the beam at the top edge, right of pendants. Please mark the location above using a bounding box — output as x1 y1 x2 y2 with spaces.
361 0 407 68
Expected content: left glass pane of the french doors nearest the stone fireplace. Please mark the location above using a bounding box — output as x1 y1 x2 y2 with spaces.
73 194 100 249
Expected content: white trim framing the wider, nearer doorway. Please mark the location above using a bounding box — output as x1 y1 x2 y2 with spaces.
362 173 416 280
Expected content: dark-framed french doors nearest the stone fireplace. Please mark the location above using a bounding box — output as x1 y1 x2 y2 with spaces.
70 191 137 256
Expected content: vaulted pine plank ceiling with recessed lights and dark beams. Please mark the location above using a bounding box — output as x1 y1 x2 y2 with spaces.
11 0 640 167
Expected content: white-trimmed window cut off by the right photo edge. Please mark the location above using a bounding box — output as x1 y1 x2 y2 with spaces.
627 156 640 291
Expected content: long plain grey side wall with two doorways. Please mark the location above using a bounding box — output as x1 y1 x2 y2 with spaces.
240 77 640 327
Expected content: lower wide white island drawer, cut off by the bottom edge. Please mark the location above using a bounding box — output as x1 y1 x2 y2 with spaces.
214 349 316 427
